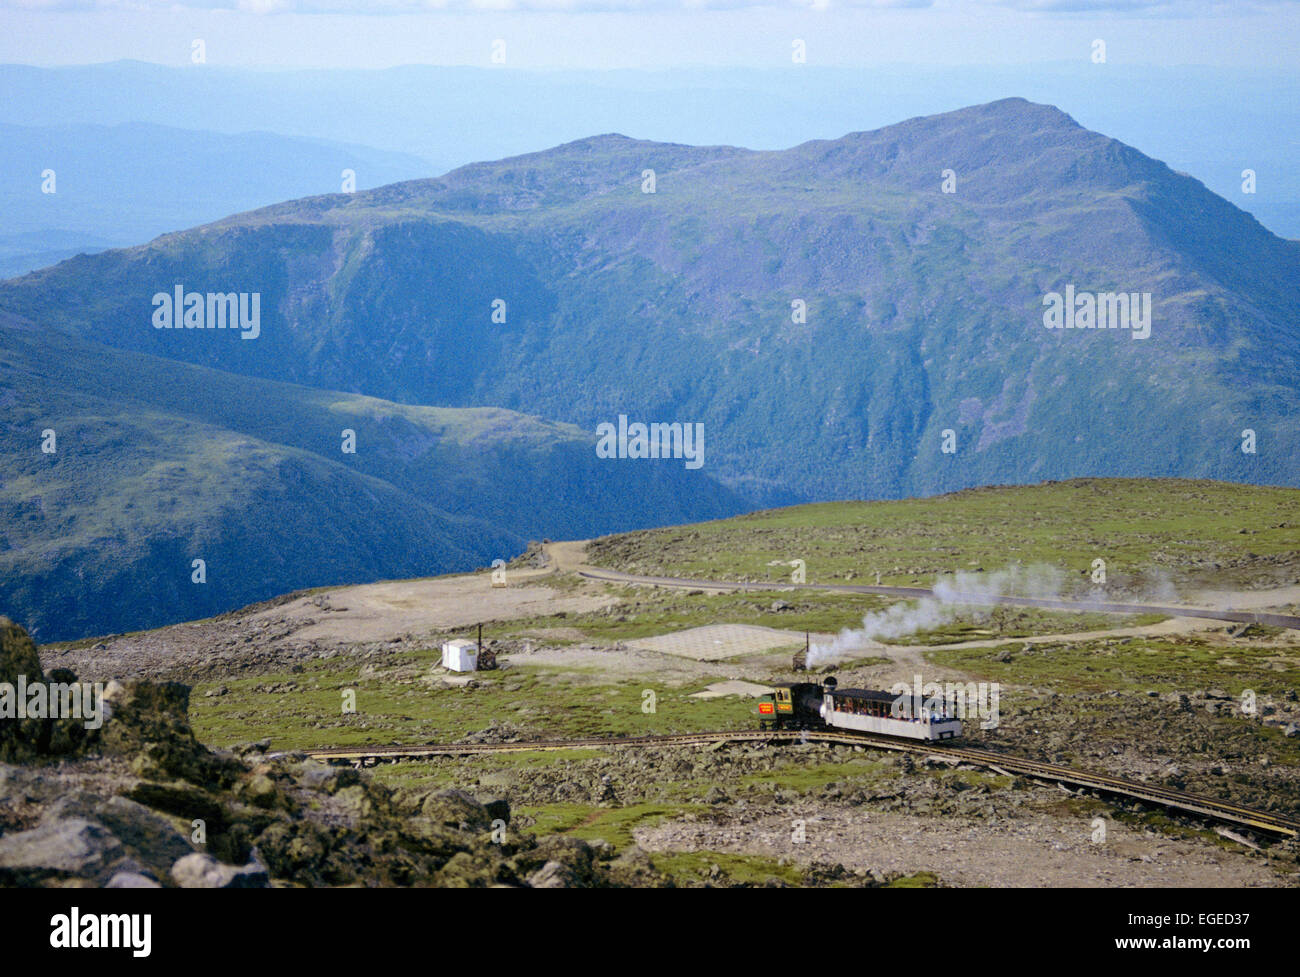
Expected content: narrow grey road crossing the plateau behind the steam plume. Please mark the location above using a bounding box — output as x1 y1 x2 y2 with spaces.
573 565 1300 630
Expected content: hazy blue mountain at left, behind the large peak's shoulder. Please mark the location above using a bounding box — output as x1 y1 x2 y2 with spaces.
0 122 438 278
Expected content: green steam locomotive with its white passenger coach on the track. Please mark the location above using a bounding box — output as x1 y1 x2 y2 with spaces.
758 677 962 739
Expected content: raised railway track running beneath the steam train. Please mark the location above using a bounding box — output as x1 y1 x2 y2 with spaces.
306 730 1300 838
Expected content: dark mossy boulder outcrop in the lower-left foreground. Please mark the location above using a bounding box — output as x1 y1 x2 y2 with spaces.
0 617 666 889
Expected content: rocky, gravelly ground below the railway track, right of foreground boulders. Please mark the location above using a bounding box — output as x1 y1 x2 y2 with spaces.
390 726 1300 887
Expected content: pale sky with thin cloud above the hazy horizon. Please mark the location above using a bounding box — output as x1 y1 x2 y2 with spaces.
0 0 1300 69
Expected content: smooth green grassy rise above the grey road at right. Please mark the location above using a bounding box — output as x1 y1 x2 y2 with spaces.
588 478 1300 596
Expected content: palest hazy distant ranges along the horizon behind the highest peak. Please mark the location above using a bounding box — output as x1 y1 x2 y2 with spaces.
0 62 1300 243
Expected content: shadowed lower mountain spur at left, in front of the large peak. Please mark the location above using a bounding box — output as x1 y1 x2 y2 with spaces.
0 313 740 641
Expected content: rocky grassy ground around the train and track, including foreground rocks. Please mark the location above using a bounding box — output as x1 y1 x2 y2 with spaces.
10 522 1300 887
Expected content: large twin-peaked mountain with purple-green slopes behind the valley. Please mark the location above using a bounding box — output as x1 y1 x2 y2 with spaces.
0 99 1300 503
